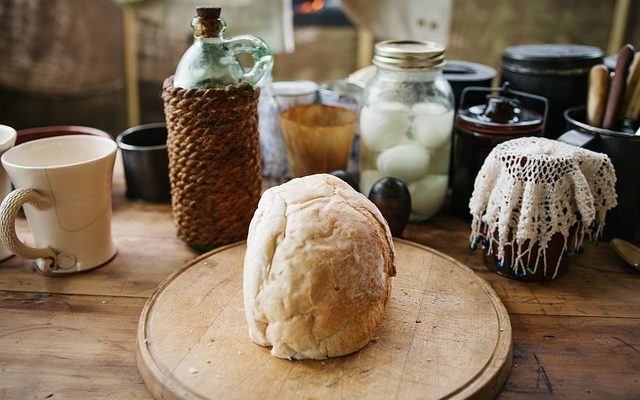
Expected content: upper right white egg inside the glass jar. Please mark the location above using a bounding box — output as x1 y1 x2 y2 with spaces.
411 103 453 149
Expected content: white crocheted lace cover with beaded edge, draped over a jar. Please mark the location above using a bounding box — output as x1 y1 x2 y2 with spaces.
469 137 617 277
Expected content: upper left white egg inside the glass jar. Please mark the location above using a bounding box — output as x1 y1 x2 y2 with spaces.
360 102 410 151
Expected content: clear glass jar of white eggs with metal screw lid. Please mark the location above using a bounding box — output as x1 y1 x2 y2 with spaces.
360 40 454 221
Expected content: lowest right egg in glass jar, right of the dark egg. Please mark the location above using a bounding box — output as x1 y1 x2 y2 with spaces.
408 174 449 220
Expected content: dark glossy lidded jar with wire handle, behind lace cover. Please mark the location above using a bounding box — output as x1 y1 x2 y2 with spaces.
451 85 548 219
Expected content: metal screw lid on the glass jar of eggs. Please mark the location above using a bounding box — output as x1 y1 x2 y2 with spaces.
373 40 445 69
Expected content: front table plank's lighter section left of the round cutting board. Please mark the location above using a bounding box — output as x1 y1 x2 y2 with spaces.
0 292 151 399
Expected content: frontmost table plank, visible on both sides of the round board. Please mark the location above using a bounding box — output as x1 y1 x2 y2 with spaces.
0 292 640 399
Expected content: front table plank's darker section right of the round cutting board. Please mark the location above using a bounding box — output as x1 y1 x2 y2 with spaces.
500 315 640 399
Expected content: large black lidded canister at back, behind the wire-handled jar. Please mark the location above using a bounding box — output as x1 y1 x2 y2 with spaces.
500 44 604 139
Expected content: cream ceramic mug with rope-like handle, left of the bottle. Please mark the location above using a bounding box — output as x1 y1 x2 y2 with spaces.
0 135 117 274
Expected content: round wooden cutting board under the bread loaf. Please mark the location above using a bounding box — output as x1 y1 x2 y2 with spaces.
136 240 512 399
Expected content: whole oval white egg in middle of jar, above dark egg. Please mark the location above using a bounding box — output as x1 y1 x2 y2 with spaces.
376 144 431 183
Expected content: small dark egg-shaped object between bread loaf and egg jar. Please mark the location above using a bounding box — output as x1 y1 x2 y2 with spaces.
369 177 411 237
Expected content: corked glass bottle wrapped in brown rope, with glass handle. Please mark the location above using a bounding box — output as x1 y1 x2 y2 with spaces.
162 7 273 251
